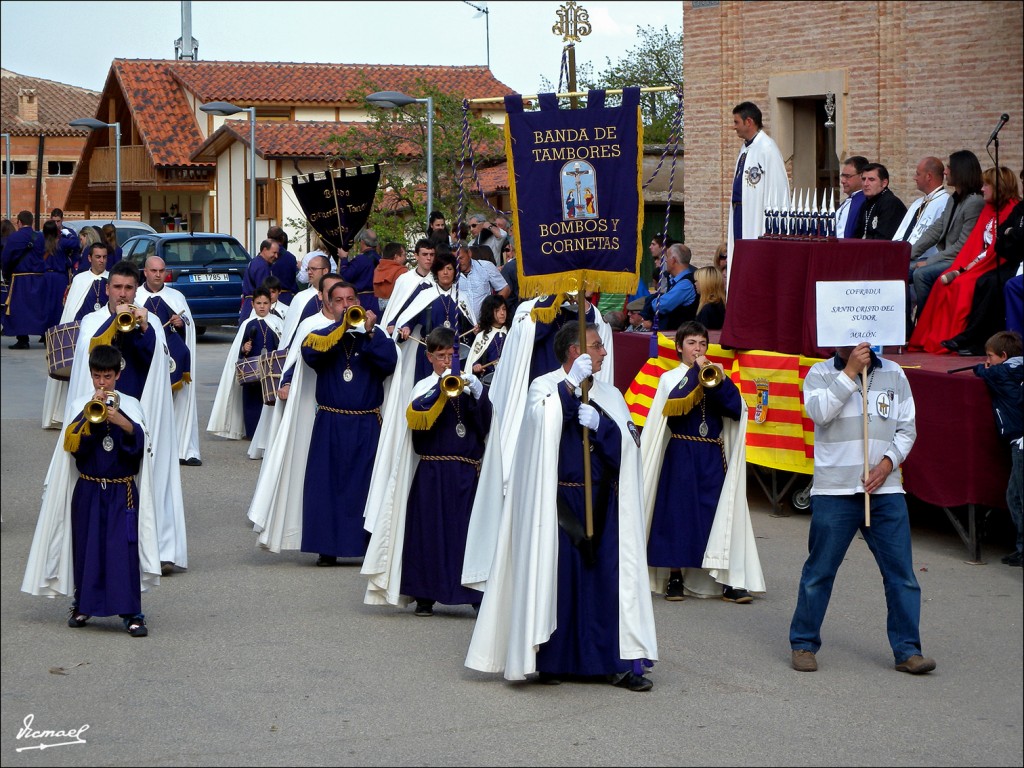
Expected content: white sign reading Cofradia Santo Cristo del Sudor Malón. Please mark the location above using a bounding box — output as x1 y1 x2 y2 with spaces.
815 280 906 347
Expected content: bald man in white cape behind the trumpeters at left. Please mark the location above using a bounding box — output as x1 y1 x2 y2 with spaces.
137 256 203 467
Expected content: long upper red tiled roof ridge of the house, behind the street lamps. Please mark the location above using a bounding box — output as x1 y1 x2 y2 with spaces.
164 61 514 109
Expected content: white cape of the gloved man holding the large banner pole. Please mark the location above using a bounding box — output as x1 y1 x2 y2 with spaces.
466 369 657 680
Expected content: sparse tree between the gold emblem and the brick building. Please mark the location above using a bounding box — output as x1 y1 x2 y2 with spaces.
541 26 683 144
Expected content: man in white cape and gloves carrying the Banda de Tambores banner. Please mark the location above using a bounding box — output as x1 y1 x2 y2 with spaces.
466 323 657 691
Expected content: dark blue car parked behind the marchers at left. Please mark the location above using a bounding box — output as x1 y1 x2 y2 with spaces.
122 232 250 334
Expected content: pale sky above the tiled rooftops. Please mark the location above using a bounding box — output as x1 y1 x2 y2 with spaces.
0 0 683 96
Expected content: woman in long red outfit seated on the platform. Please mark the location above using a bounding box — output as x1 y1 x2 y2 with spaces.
907 166 1020 354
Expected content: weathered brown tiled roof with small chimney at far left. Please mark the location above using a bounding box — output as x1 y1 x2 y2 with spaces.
0 70 99 136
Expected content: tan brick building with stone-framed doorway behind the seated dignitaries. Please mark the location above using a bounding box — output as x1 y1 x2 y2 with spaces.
683 0 1024 263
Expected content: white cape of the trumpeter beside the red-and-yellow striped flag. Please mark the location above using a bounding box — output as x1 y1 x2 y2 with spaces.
640 366 766 597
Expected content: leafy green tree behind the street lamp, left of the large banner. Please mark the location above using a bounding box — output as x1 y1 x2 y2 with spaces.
329 73 505 243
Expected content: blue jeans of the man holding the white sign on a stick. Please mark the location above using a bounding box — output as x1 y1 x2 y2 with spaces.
790 494 921 664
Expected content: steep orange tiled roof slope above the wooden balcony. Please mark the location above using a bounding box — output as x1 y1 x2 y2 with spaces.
112 58 207 166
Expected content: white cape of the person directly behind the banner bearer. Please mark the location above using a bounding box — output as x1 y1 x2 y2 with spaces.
462 297 615 590
